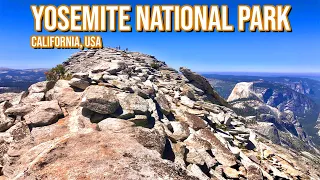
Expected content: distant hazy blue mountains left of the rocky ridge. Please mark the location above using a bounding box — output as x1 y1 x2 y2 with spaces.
0 67 48 93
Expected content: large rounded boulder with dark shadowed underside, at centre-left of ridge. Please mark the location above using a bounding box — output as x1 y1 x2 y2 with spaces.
80 86 119 114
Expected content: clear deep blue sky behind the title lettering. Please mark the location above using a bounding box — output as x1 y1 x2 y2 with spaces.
0 0 320 73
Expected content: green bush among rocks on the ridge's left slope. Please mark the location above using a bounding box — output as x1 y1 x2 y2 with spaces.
45 64 72 81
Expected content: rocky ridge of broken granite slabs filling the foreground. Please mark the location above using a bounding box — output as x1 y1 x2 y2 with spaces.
0 48 320 180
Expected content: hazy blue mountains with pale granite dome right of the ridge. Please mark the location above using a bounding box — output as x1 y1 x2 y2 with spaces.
205 74 320 145
